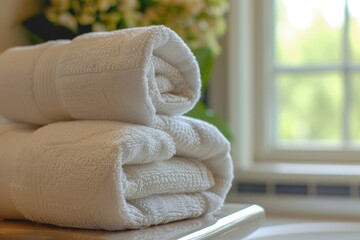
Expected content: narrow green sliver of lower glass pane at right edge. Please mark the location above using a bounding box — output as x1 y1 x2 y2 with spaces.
350 73 360 141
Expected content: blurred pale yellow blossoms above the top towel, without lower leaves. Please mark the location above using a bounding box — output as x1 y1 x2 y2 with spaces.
45 0 229 54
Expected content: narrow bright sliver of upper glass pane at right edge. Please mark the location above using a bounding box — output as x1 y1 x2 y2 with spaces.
348 0 360 64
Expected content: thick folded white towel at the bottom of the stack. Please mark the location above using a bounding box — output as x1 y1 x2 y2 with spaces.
0 117 233 230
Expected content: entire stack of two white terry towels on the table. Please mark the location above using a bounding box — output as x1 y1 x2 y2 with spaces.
0 26 233 230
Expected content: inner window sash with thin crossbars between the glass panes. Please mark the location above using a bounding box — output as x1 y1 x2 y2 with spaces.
262 0 360 164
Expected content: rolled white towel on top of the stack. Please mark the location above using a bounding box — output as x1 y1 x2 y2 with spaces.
0 26 200 125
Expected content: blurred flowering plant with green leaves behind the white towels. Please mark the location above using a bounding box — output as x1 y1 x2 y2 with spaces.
24 0 229 139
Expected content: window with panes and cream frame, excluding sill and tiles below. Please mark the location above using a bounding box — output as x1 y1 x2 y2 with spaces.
229 0 360 165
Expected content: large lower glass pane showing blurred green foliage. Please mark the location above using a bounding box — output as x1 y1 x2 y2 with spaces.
276 73 343 144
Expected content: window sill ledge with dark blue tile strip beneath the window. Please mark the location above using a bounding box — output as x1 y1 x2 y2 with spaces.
227 163 360 219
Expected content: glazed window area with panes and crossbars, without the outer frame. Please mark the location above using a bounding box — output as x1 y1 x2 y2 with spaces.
269 0 360 148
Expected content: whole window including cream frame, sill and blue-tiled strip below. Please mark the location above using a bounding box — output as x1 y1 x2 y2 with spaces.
227 0 360 217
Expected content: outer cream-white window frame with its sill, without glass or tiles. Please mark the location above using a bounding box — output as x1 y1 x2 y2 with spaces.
227 0 360 177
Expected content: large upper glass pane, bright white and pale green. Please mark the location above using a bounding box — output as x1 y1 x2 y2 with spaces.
275 0 344 65
